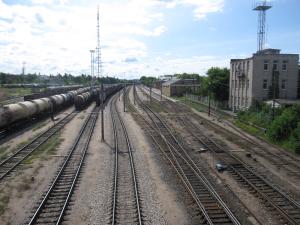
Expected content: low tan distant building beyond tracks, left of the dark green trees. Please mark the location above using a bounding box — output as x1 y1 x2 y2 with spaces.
162 79 199 96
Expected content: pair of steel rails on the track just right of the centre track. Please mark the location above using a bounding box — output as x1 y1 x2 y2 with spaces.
131 85 240 224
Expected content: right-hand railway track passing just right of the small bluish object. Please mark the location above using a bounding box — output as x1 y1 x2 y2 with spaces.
181 118 300 225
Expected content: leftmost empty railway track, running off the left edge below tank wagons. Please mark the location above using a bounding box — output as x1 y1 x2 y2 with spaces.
0 111 77 181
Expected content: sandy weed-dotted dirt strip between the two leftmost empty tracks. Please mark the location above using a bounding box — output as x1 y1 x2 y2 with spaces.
0 103 92 225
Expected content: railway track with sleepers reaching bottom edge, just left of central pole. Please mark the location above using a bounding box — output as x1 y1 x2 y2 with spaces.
28 107 99 225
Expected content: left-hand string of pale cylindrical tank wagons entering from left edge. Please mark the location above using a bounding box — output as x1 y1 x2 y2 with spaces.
0 88 89 130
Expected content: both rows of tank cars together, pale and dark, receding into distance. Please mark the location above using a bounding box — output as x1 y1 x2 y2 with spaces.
0 85 122 130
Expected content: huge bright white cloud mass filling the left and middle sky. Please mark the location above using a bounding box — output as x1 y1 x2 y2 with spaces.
0 0 223 76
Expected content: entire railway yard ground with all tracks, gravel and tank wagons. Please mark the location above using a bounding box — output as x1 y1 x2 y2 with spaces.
0 85 300 225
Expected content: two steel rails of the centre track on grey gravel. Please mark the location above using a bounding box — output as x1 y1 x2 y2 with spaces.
111 91 142 225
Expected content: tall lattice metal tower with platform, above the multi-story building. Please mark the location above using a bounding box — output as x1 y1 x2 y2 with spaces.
253 0 272 51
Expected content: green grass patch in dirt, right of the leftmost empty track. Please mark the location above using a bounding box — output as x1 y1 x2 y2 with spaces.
24 132 64 164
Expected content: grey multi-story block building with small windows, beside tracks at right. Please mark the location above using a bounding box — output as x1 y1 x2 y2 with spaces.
229 49 299 111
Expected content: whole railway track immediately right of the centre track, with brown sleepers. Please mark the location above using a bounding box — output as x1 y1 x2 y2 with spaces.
130 85 240 225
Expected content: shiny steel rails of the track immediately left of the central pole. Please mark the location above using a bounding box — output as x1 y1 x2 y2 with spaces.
28 107 99 225
